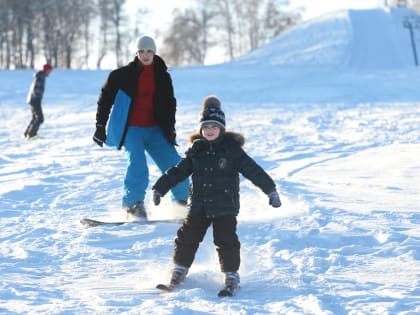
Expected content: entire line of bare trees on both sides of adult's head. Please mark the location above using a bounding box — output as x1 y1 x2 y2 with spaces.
0 0 300 69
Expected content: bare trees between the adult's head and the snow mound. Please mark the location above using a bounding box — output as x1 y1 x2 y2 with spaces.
162 0 301 65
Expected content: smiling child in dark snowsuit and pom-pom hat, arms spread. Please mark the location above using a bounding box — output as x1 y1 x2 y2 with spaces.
153 96 281 295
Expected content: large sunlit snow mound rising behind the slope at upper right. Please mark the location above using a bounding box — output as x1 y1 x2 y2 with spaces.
237 8 420 69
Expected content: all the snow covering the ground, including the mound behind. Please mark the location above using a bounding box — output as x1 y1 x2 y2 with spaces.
0 9 420 315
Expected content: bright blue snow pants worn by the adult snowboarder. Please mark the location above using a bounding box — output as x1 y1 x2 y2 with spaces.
122 126 189 207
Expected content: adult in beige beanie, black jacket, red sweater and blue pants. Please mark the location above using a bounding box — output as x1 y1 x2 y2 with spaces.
93 36 189 220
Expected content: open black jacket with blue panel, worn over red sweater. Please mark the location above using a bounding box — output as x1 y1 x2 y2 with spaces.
96 55 176 150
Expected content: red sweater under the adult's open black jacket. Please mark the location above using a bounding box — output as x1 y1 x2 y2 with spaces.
129 64 157 127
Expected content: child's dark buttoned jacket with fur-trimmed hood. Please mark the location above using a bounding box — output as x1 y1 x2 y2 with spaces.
153 132 275 218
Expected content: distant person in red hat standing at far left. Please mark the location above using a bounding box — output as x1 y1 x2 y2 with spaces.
24 63 52 139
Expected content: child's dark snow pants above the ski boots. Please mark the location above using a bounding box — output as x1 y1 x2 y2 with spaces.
173 214 241 272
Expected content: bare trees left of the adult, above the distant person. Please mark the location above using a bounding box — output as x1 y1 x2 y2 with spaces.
0 0 138 69
